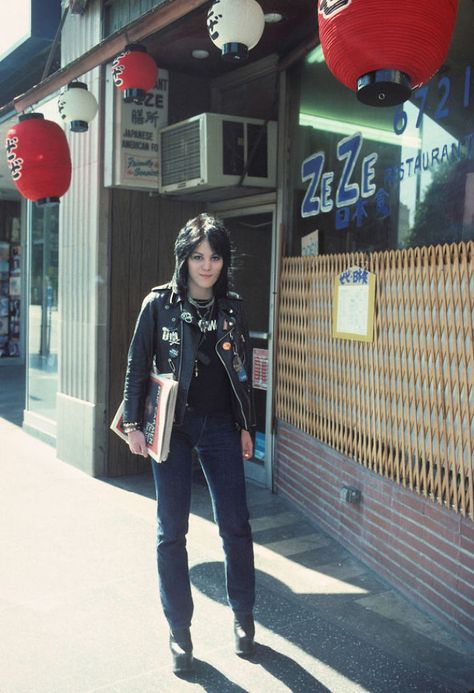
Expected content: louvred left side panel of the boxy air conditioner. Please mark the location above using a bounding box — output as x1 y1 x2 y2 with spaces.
161 120 201 185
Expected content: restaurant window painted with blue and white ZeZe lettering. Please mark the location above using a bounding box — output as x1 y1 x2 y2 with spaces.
289 3 474 255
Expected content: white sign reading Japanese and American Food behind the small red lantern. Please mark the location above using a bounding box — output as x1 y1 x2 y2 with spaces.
104 69 168 191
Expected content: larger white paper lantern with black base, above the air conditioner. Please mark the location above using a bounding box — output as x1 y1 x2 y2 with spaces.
207 0 265 61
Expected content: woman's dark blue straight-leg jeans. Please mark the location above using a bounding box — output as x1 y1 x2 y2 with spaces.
152 410 255 629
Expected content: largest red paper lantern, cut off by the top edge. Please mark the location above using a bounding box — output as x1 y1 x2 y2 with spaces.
318 0 458 106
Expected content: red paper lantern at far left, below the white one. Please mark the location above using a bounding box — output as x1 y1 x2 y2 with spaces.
5 113 71 204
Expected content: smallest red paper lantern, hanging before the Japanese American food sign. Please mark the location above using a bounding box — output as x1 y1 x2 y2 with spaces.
112 44 158 103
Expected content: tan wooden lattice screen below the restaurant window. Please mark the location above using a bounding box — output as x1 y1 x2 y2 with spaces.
276 241 474 519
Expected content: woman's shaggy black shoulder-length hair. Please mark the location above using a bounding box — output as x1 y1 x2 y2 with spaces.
172 213 232 298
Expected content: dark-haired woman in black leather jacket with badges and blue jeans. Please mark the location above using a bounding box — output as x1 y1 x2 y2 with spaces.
124 214 255 673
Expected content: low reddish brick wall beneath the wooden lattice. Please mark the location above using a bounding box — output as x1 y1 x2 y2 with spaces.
275 421 474 640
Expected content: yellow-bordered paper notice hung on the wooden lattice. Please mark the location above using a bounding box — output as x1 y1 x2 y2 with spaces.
332 267 375 342
